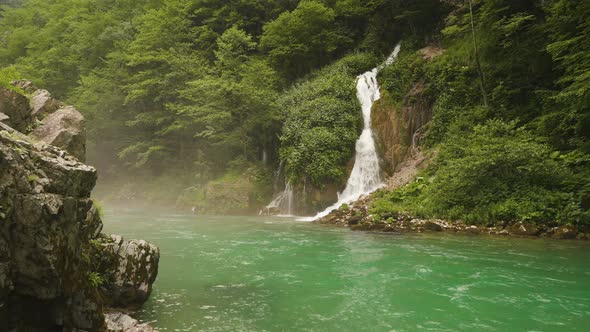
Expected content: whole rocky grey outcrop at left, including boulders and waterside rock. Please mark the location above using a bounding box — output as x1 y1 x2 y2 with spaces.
0 82 159 331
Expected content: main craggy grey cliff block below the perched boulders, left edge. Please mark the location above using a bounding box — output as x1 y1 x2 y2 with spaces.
0 123 104 331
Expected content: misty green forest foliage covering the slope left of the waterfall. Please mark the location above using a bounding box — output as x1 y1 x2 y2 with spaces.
0 0 445 210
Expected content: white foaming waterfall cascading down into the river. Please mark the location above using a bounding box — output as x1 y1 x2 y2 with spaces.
301 44 401 221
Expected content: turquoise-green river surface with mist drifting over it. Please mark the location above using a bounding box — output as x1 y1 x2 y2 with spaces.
104 209 590 332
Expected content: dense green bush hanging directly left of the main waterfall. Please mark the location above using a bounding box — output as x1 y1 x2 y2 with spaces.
278 53 377 188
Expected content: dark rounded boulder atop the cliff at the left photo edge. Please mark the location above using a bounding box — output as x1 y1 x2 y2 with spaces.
0 88 31 131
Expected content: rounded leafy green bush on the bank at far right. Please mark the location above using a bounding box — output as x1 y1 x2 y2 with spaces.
421 120 587 223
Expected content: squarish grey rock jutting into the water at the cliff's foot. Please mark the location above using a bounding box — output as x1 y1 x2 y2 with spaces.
99 235 160 307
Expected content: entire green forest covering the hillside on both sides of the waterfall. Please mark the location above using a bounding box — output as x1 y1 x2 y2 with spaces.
0 0 590 224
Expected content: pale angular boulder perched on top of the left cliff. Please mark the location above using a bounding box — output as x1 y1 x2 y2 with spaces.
31 106 86 161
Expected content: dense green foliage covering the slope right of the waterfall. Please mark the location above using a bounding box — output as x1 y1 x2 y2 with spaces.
371 0 590 223
